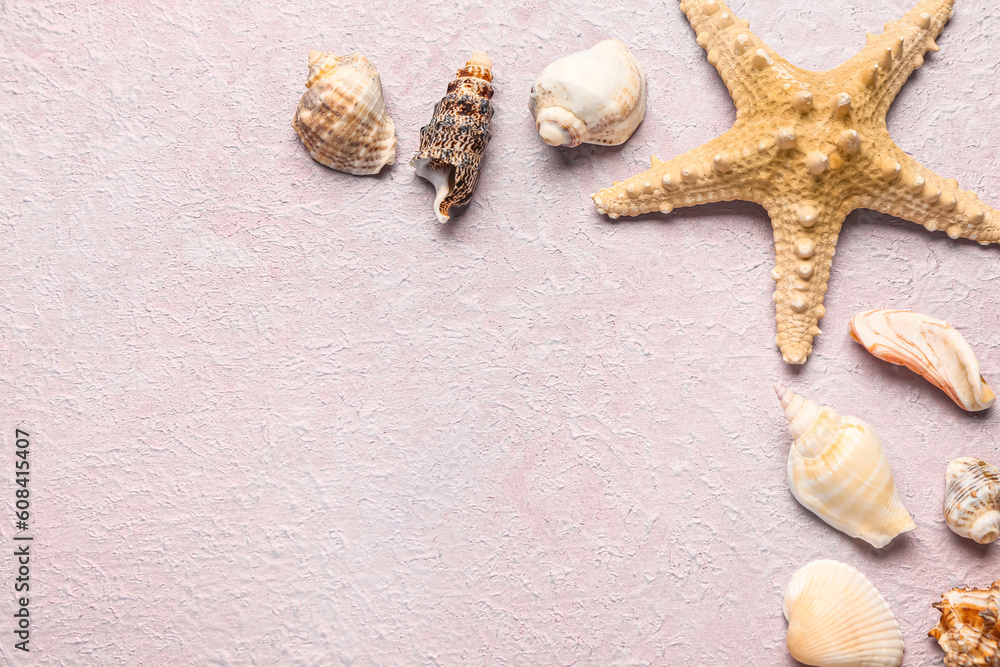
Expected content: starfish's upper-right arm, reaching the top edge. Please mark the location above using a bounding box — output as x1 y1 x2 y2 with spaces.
833 0 955 122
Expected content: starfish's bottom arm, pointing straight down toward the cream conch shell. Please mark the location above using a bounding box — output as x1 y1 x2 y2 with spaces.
765 200 849 364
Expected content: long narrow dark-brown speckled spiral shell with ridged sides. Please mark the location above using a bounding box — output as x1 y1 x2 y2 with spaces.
410 51 493 224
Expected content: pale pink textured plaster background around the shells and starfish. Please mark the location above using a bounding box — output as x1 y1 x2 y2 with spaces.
0 0 1000 667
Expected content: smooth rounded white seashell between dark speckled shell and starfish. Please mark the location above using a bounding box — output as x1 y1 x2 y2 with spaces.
528 39 646 146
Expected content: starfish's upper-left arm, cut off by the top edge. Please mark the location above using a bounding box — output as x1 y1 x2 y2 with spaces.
680 0 798 116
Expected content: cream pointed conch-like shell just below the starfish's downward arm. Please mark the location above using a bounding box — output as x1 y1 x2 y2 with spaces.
774 385 916 549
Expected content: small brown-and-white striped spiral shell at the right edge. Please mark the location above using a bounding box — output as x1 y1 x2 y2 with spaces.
944 457 1000 544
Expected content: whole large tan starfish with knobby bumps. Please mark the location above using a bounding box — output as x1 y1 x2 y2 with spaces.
593 0 1000 364
